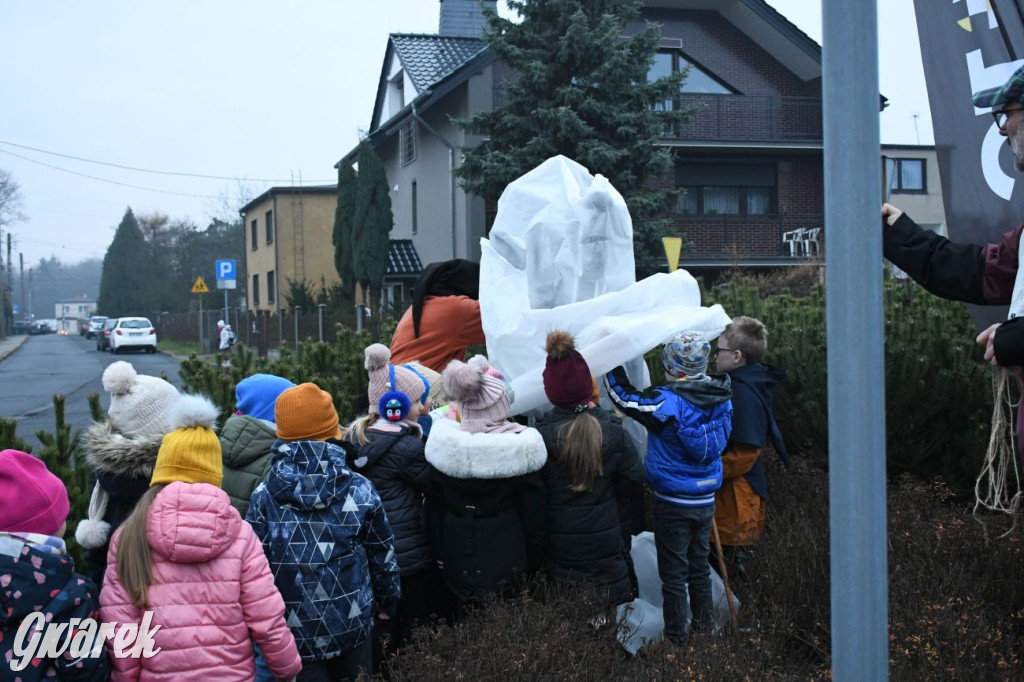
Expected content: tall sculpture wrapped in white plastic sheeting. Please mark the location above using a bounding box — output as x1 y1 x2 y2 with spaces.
480 157 729 414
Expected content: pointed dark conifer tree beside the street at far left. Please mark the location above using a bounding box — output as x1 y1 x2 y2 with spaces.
97 208 154 315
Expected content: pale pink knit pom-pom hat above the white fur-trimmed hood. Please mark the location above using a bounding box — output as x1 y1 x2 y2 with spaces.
441 355 526 433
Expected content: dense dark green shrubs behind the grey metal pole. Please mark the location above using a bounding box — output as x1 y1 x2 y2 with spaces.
707 280 992 493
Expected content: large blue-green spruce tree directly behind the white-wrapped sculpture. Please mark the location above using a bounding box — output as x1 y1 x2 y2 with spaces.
457 0 687 260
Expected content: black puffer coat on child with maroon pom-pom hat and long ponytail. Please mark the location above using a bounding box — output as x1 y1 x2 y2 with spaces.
537 408 644 603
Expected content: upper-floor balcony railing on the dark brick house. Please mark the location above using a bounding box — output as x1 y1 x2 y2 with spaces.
665 94 821 142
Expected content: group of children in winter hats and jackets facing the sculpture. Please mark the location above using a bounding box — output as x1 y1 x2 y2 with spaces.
0 311 784 682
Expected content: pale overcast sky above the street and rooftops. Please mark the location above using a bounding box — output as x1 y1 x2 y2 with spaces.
0 0 933 270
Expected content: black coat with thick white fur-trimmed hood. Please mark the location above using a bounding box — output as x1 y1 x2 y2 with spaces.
427 419 547 603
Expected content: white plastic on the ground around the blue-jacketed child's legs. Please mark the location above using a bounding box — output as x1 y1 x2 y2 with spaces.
616 531 739 655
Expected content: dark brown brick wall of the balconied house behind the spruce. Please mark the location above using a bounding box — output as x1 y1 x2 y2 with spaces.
629 9 824 261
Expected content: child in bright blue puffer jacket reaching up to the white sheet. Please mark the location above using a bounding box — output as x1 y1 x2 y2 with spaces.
606 332 732 643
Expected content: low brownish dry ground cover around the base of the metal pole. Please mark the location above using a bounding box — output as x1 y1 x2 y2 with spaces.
380 460 1024 682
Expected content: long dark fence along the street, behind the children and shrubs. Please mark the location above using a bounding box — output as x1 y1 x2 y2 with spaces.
153 304 402 357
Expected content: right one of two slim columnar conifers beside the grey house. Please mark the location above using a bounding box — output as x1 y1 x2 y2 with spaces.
352 142 394 311
